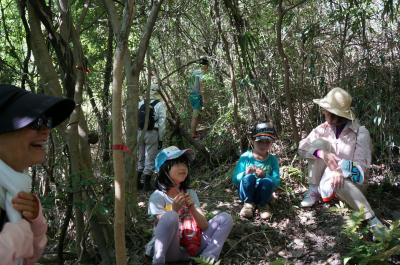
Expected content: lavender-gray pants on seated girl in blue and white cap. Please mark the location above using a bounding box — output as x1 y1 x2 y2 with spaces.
153 211 233 264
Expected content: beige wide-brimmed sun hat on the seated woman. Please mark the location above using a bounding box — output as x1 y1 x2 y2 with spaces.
313 87 356 121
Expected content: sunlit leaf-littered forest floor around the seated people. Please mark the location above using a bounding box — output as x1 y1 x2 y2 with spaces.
130 159 400 265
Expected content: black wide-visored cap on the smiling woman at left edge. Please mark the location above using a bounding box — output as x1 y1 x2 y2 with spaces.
0 84 75 133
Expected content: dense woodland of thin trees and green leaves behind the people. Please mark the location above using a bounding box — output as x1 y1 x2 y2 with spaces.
0 0 400 264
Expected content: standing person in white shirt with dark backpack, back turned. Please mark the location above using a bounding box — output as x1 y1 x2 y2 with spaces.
137 84 167 191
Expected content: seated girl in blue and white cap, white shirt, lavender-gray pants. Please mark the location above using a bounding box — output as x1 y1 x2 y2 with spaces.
146 146 233 264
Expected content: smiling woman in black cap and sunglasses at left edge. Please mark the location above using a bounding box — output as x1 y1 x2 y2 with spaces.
0 85 75 265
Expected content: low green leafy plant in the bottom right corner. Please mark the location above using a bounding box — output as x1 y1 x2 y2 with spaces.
343 209 400 264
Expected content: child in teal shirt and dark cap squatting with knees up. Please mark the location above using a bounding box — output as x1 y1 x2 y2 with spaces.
232 122 280 219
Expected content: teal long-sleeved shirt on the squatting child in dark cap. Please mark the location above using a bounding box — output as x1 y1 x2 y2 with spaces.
232 150 281 189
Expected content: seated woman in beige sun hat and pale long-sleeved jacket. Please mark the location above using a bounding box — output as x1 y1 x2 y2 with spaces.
299 87 382 231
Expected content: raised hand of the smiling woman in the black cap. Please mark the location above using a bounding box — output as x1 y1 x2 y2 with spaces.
12 191 39 222
